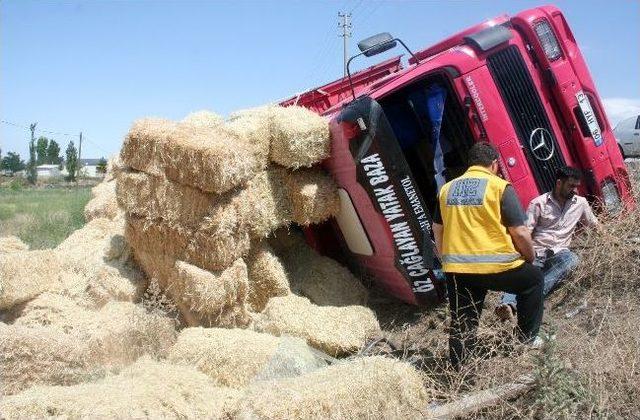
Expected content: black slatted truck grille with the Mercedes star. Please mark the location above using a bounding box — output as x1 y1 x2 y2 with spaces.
487 46 565 192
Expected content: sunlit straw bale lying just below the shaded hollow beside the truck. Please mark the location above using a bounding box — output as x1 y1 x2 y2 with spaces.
255 295 380 356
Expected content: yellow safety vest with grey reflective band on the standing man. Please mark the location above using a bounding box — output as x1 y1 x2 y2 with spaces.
439 166 524 274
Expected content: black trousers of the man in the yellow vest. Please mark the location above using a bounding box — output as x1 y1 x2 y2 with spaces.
447 263 544 368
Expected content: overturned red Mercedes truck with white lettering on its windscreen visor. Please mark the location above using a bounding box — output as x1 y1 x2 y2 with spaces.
281 6 632 305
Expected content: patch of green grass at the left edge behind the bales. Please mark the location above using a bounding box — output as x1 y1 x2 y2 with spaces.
0 187 91 249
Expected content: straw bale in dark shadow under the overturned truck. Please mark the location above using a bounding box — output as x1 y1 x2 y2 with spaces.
280 235 368 306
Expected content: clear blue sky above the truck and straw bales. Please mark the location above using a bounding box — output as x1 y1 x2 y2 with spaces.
0 0 640 159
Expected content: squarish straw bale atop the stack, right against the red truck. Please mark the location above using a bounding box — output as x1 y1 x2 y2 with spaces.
271 106 330 169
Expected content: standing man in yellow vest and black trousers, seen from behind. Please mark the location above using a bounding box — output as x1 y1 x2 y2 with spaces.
433 142 544 368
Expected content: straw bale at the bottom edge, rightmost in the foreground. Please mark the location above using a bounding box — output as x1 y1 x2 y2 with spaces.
239 356 429 419
